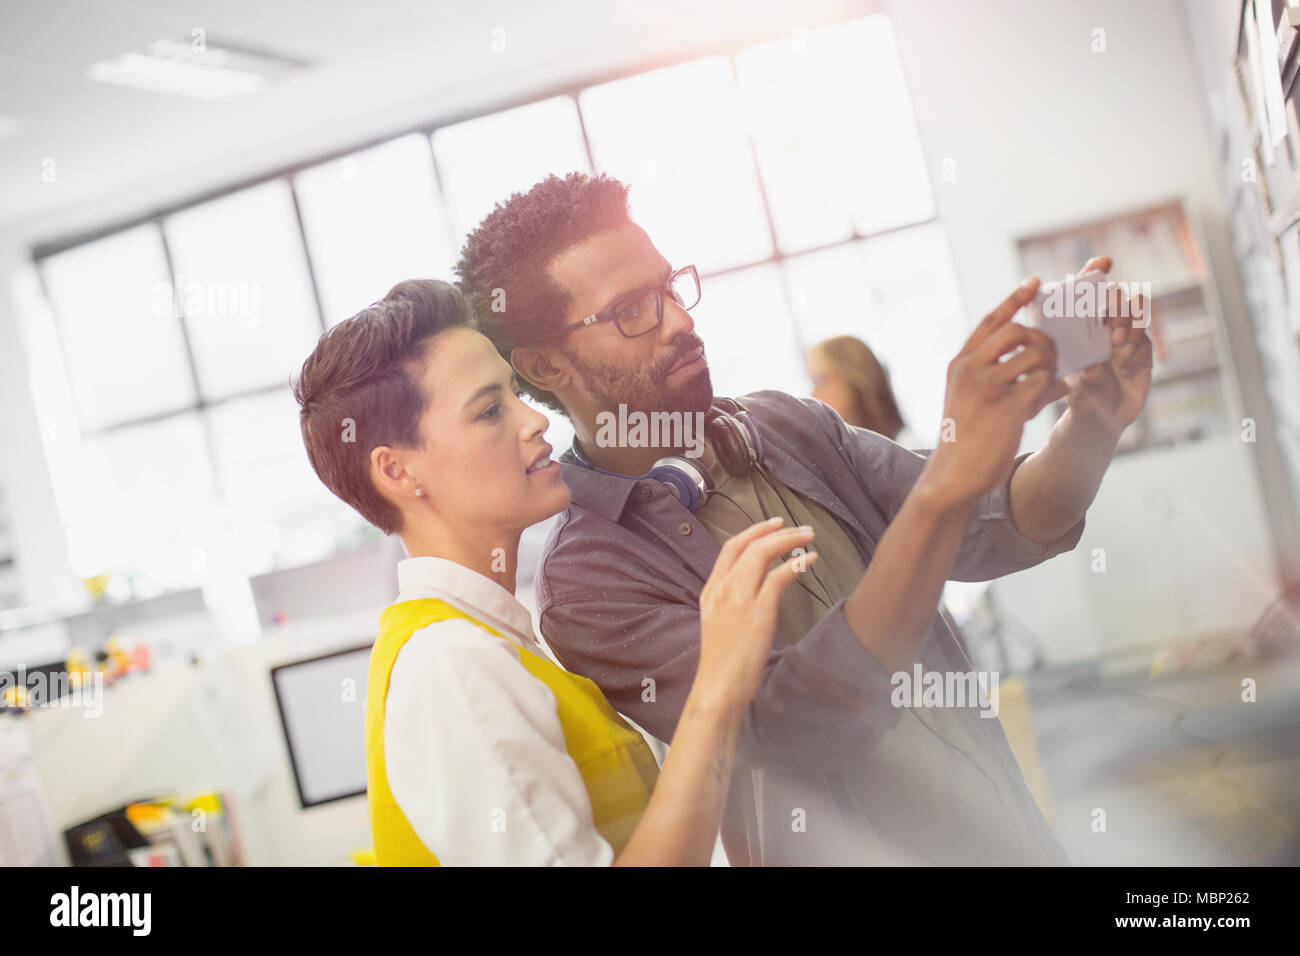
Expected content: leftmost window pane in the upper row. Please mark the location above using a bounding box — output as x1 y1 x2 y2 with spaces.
42 225 195 431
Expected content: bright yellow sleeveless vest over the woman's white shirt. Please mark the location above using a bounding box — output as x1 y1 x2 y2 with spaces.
365 598 659 866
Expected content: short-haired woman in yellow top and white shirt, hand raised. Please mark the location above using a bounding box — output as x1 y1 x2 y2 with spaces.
294 280 815 865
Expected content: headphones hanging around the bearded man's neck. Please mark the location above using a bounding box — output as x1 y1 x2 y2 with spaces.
573 398 763 511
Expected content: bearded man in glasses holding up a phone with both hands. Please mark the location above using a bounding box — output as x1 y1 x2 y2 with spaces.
458 173 1151 865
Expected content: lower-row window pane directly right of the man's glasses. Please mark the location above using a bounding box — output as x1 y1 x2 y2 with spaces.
690 265 810 397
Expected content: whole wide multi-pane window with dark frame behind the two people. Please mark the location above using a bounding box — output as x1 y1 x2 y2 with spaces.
29 16 965 596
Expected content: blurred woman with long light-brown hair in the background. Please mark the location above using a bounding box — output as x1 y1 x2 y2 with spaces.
806 336 920 447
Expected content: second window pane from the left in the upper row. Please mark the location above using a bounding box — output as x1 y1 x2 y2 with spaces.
163 179 320 398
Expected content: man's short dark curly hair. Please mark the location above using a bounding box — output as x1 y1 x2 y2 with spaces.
456 173 631 414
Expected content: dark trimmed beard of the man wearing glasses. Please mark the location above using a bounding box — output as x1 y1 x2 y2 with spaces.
564 333 714 415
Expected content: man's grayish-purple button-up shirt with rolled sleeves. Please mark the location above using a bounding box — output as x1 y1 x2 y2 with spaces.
537 392 1083 865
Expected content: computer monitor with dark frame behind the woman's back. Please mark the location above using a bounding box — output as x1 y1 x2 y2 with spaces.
270 644 371 808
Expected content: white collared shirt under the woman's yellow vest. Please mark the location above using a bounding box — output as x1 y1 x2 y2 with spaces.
384 557 614 866
